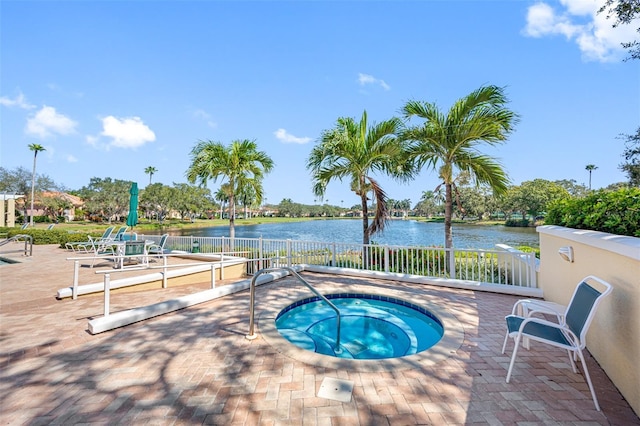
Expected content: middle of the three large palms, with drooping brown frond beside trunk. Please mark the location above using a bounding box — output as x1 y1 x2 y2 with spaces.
307 111 414 244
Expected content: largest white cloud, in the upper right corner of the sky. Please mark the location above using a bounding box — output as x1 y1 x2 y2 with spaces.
523 0 639 62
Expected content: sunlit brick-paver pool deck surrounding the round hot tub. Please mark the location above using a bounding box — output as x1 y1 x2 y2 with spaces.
0 245 640 425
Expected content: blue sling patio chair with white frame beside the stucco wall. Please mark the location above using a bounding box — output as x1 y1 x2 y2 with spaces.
502 275 612 411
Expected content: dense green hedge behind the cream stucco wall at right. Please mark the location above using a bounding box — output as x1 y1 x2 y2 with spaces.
545 188 640 237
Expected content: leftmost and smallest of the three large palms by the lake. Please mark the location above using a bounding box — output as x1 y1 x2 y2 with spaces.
186 139 273 239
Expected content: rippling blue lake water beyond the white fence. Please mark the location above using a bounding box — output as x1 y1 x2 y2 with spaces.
162 219 540 249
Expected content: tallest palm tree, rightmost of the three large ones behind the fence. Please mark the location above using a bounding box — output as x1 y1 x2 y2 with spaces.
402 86 518 248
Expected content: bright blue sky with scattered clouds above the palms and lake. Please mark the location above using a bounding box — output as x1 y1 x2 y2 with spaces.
0 0 640 207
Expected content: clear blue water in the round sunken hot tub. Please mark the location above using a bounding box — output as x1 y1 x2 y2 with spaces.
276 293 444 359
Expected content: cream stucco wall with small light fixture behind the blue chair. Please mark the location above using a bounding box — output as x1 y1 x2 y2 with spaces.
537 226 640 414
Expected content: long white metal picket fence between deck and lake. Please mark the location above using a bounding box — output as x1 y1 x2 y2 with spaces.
141 235 537 288
